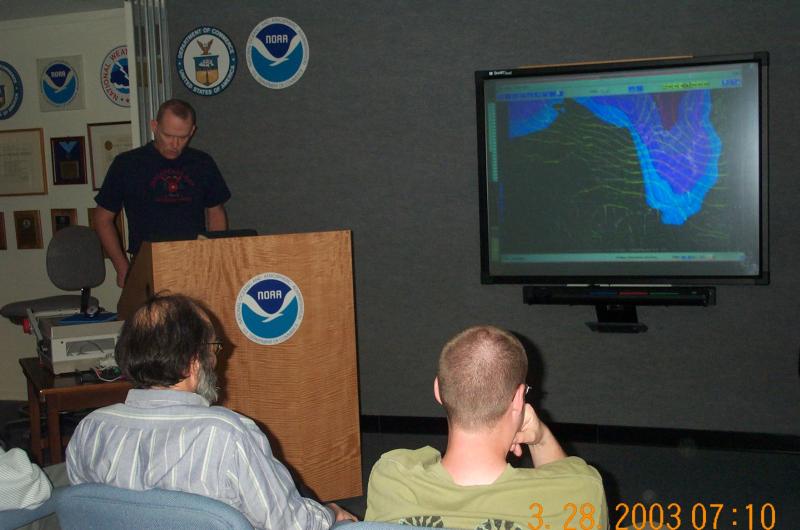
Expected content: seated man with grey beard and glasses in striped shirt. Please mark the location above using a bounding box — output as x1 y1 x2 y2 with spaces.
67 295 355 530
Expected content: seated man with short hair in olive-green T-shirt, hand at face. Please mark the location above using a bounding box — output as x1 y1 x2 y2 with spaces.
365 326 608 530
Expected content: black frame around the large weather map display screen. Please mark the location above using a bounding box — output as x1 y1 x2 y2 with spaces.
475 52 769 285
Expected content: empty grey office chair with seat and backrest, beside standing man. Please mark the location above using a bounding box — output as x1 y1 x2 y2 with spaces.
0 226 106 324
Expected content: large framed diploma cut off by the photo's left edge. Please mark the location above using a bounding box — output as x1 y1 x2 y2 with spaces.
0 129 47 196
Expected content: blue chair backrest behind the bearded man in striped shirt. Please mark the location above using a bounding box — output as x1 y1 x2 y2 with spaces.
56 484 253 530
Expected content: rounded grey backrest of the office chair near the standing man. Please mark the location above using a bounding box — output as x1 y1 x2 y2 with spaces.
47 226 106 291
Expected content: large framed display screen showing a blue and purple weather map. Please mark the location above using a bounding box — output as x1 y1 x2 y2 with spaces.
475 53 768 284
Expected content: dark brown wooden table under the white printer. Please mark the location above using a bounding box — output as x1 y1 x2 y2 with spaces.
19 357 131 465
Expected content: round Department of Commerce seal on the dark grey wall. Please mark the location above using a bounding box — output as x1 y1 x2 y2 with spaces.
175 26 236 96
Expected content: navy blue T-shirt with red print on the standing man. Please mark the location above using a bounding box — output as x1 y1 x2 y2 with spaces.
94 142 231 254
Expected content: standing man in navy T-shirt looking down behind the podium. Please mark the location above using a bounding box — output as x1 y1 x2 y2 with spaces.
94 99 231 287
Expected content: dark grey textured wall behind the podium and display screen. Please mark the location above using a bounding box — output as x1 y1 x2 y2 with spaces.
168 0 800 434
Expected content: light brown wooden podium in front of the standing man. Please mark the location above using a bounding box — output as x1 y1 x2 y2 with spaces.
118 231 362 501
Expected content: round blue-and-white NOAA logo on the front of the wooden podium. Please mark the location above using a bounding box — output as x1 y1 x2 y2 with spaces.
236 272 303 345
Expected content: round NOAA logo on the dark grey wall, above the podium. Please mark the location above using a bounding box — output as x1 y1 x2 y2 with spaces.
247 17 308 88
